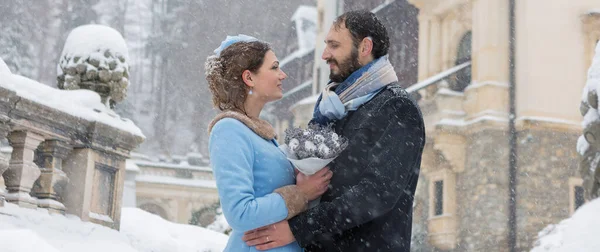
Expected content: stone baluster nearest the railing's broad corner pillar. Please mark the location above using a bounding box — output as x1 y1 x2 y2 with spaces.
33 140 73 213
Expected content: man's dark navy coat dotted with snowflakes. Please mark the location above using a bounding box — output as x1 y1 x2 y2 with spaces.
289 83 425 252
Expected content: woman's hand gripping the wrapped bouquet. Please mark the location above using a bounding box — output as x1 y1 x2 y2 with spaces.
296 167 333 200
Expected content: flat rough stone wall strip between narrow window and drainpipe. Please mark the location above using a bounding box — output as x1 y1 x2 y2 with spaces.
455 130 508 251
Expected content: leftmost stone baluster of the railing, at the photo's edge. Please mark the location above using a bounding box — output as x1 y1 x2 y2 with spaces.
2 130 44 208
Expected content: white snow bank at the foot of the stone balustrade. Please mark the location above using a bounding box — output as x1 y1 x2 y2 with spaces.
0 203 228 252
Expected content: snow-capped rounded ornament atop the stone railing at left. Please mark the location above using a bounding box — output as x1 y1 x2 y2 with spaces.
57 25 129 107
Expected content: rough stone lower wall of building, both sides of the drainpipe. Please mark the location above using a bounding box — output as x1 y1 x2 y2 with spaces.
412 124 580 252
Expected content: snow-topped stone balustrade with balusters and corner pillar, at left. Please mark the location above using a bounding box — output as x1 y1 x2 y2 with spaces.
0 57 144 229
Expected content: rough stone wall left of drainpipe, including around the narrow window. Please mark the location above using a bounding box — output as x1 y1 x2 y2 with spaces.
411 129 508 252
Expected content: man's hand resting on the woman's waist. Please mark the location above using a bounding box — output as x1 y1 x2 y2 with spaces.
242 220 296 250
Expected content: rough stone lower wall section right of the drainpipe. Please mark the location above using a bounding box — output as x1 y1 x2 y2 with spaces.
517 129 580 251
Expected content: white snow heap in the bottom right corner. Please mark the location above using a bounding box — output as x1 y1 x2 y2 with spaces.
531 199 600 252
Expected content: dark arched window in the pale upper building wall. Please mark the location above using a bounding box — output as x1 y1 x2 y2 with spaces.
450 31 471 92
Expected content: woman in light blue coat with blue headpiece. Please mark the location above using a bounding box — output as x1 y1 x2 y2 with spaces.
206 36 332 252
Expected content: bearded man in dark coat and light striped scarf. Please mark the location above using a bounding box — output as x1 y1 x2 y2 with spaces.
243 11 425 251
